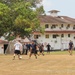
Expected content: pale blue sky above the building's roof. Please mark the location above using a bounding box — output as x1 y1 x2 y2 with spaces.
42 0 75 18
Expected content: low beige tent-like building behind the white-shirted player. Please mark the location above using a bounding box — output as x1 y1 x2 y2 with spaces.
5 36 32 54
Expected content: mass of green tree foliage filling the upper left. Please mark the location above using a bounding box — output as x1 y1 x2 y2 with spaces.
0 0 44 39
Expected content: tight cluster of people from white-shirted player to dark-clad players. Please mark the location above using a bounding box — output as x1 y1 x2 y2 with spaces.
13 40 44 60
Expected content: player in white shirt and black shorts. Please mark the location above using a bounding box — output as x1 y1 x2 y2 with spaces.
13 40 22 60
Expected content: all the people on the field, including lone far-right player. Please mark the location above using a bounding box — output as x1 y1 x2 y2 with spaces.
13 40 74 60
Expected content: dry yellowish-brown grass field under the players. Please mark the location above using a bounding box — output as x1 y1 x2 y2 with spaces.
0 51 75 75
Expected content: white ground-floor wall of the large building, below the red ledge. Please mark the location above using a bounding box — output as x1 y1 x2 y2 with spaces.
32 33 75 50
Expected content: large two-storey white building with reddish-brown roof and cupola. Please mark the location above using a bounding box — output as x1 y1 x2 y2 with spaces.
31 10 75 50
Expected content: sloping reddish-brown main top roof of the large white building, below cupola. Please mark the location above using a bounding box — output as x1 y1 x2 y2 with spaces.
39 15 75 24
